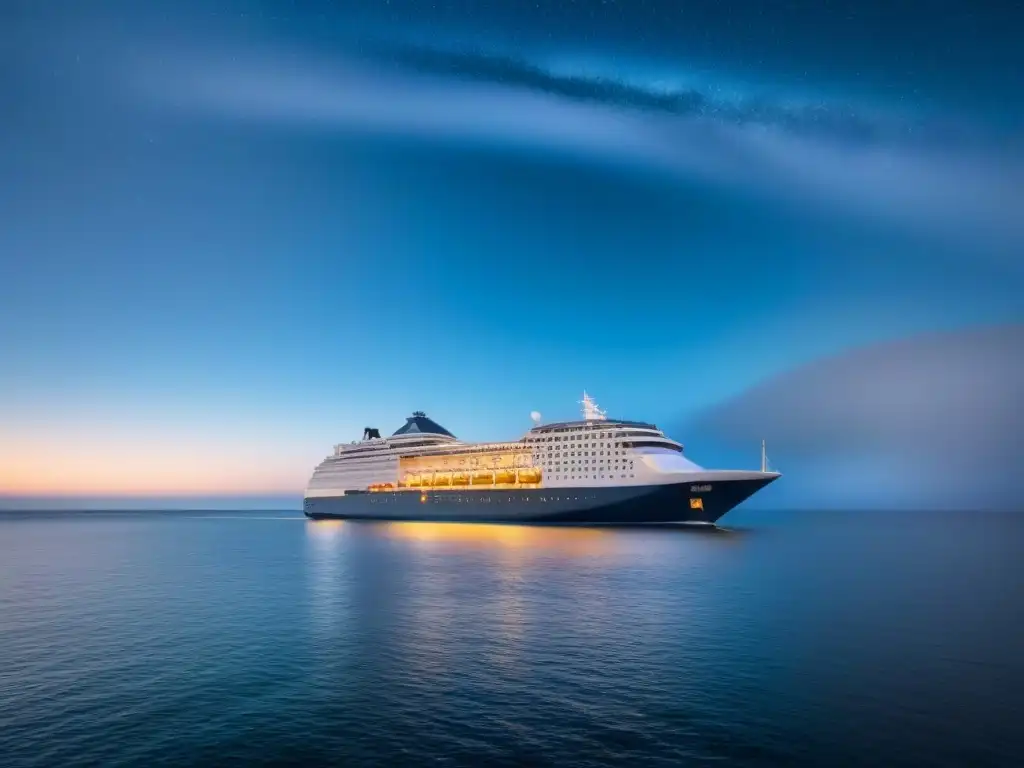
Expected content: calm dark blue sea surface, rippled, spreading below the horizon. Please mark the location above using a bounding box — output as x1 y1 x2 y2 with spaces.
0 510 1024 768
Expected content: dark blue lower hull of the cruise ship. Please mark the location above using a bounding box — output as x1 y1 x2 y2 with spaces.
303 475 777 525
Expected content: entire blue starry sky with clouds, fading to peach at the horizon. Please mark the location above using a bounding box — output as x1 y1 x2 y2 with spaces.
0 0 1024 507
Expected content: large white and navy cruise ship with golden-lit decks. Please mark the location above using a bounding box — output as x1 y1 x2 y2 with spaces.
303 392 779 525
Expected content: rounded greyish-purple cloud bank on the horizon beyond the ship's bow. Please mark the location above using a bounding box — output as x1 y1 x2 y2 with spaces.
694 326 1024 508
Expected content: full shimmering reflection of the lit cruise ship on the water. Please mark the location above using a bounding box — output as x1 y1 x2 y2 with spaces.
306 521 753 716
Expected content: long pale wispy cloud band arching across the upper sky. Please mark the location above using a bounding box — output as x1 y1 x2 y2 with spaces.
130 42 1024 256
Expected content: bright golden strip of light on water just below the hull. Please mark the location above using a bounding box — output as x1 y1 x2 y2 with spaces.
380 522 616 557
